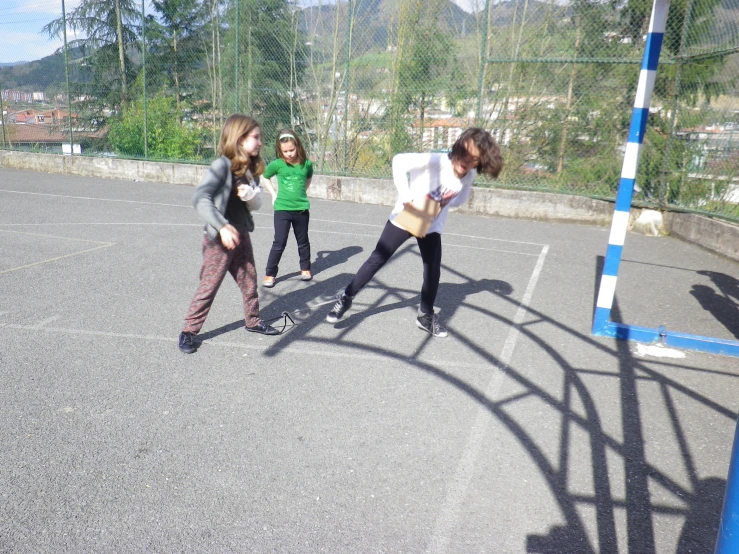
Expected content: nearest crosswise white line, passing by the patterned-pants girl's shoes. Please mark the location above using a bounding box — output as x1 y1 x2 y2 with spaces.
0 322 498 370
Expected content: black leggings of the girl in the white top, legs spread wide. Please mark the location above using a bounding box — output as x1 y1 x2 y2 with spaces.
344 221 441 314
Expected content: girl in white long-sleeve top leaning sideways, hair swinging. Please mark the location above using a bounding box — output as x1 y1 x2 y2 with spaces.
326 128 503 337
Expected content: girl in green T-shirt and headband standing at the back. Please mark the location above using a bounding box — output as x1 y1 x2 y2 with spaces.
263 129 313 288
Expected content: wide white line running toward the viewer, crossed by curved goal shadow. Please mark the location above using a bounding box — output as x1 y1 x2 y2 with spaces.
426 246 549 554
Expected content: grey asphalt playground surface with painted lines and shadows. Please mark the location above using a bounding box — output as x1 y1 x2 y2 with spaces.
0 166 739 554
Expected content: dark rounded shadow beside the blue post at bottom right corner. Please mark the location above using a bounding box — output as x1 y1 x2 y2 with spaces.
675 477 726 554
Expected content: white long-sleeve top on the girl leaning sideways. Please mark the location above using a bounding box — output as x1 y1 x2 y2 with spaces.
390 154 477 234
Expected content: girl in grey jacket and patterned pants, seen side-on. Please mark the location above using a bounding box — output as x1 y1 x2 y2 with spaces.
179 114 279 354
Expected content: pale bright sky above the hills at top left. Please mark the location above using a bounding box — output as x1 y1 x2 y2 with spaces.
0 0 484 64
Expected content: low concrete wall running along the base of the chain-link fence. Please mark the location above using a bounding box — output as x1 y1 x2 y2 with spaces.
0 150 739 261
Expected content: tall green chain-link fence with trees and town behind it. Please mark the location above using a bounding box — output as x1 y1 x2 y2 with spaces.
0 0 739 221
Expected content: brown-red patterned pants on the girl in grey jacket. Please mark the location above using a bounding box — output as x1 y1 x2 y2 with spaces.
182 231 261 334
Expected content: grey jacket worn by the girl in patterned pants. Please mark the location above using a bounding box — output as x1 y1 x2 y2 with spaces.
192 156 254 240
